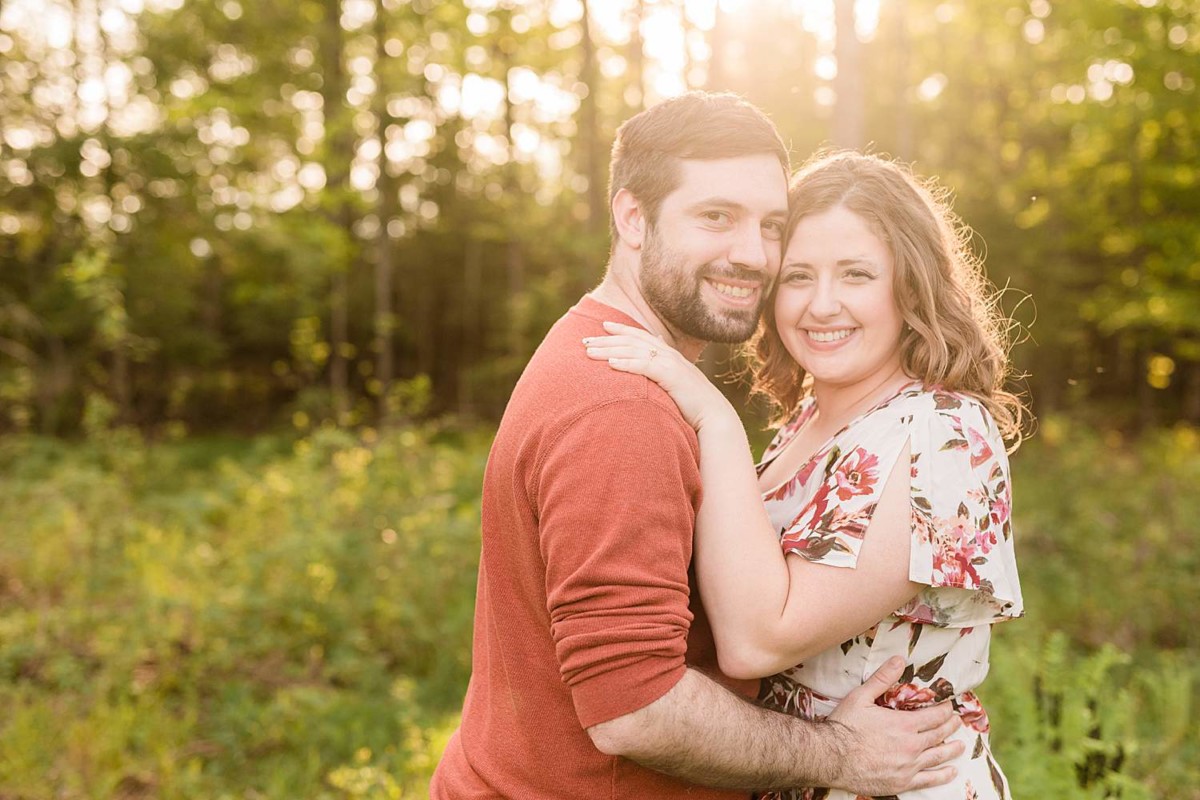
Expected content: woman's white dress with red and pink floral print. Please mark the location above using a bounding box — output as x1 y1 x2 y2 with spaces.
760 384 1022 800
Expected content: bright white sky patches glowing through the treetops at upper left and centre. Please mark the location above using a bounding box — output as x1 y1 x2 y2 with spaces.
0 0 902 226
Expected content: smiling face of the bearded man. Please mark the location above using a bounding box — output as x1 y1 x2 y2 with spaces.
641 154 787 342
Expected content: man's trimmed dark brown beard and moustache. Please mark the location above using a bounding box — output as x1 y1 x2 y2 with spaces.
641 225 767 343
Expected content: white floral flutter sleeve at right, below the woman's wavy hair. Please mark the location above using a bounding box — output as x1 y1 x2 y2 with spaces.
896 391 1024 627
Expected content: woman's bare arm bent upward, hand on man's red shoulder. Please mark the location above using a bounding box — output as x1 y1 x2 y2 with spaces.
587 324 920 678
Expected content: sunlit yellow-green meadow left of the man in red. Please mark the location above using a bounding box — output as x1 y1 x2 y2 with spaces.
0 422 487 798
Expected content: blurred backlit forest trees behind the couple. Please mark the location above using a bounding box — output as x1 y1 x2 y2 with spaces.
0 0 1200 434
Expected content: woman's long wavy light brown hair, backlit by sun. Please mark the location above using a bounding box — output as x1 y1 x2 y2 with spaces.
748 152 1027 450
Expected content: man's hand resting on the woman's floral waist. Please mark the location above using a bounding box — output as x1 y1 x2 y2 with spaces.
828 656 966 796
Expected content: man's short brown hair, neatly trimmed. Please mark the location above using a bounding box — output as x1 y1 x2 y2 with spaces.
608 91 791 245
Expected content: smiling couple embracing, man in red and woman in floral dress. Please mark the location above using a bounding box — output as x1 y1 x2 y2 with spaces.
431 92 1021 800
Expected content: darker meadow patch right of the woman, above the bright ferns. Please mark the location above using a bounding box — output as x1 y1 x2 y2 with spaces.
1013 417 1200 652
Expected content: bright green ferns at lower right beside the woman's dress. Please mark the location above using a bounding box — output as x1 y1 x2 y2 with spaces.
982 628 1200 800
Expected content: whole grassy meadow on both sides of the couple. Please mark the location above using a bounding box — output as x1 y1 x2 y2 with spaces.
0 420 1200 800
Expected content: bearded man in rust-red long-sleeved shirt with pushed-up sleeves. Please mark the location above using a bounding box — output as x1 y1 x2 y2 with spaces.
431 92 960 800
